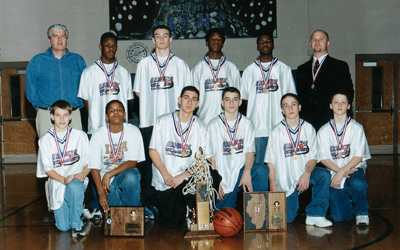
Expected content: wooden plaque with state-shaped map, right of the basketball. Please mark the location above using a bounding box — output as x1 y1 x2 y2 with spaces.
243 192 287 232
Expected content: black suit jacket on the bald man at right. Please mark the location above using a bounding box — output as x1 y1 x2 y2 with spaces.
296 55 354 131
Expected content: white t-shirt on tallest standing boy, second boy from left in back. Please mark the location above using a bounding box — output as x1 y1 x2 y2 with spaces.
133 53 192 128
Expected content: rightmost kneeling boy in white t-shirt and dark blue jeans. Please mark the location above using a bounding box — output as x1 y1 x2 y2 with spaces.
318 91 371 226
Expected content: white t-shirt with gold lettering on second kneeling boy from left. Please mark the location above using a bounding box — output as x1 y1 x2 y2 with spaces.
89 123 145 182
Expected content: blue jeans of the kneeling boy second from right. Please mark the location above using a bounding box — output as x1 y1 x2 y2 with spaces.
286 167 331 223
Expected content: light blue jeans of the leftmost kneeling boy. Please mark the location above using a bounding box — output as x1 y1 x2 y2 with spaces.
54 179 85 231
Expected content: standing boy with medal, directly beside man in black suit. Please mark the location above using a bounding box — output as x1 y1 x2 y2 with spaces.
241 33 296 164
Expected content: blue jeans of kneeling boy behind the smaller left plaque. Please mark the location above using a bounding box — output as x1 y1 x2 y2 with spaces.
107 168 140 206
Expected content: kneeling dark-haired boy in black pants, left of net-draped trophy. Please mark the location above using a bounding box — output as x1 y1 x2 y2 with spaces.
149 86 211 228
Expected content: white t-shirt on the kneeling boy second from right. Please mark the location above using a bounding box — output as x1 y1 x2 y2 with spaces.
264 119 317 197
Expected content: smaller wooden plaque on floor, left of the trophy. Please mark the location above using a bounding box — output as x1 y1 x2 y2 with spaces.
104 207 144 236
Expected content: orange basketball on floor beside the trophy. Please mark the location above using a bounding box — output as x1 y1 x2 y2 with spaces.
213 207 243 237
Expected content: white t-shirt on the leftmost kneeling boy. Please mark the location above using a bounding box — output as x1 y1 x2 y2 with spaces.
36 127 89 210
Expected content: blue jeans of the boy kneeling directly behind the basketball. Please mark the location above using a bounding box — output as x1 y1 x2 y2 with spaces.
216 164 269 210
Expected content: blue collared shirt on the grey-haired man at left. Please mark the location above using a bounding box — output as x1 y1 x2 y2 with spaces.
25 48 86 110
